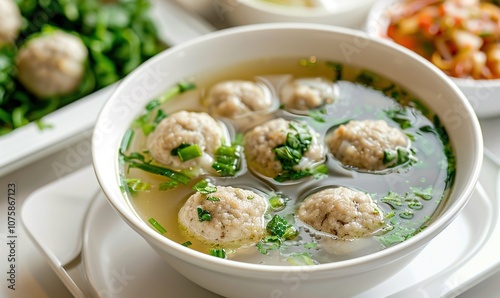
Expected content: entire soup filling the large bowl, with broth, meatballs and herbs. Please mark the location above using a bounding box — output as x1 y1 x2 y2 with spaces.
120 59 455 266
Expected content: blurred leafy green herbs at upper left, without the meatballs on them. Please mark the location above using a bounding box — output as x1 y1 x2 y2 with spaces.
0 0 167 135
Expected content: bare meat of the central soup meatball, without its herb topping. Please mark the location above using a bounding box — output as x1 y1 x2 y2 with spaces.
244 118 326 177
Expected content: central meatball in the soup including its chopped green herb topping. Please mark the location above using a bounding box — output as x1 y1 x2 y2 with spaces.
244 118 326 178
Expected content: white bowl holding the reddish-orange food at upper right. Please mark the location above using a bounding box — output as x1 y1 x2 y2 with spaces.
362 0 500 118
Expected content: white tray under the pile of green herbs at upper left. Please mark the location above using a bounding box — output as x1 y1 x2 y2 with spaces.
0 0 215 176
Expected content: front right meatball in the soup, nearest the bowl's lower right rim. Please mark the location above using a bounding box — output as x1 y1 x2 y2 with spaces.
297 187 384 239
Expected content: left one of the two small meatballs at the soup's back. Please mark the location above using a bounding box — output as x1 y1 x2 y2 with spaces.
205 80 272 118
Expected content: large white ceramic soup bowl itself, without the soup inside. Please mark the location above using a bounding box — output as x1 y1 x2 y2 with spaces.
92 24 483 297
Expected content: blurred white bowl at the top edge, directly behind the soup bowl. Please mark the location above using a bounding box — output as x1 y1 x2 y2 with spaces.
177 0 375 28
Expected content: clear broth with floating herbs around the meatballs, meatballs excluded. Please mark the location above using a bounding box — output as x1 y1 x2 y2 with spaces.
120 57 455 265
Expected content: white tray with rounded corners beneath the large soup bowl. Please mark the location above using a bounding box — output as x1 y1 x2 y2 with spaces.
21 152 500 298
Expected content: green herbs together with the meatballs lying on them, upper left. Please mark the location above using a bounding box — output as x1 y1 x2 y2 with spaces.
0 0 166 135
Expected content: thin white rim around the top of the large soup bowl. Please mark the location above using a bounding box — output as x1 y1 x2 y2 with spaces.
92 23 483 276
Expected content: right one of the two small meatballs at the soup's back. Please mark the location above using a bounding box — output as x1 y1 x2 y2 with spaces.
280 78 338 110
